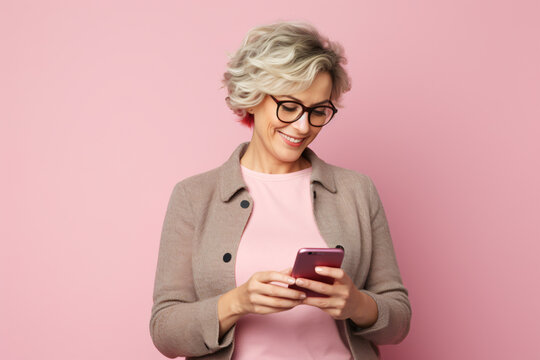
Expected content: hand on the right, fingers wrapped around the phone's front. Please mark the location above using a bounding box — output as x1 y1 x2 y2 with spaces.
296 266 378 327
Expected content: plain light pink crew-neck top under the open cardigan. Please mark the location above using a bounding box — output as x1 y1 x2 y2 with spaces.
233 166 352 360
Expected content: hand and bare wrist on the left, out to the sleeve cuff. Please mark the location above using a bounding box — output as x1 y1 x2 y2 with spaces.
218 268 306 338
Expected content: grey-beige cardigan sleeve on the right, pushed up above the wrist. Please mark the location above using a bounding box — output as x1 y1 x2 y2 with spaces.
349 179 411 345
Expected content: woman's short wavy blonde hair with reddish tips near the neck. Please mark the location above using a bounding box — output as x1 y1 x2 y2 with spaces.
222 21 351 127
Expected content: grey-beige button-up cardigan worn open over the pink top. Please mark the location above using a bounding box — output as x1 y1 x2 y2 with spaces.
150 143 411 360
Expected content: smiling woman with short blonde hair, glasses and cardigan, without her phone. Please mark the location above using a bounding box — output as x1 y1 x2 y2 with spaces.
150 22 411 359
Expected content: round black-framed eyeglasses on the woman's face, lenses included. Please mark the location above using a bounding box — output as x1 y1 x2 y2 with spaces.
270 95 337 127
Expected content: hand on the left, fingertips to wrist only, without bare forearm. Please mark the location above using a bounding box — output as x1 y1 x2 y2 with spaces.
236 268 306 315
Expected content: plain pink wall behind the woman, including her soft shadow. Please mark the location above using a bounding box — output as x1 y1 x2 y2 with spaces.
0 0 540 360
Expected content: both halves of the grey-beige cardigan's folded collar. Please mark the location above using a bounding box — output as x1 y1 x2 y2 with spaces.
218 142 337 201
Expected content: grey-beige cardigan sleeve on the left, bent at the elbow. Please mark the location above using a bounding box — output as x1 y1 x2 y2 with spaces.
150 182 234 359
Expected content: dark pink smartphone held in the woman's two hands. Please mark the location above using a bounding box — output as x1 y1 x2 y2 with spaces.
289 248 344 297
